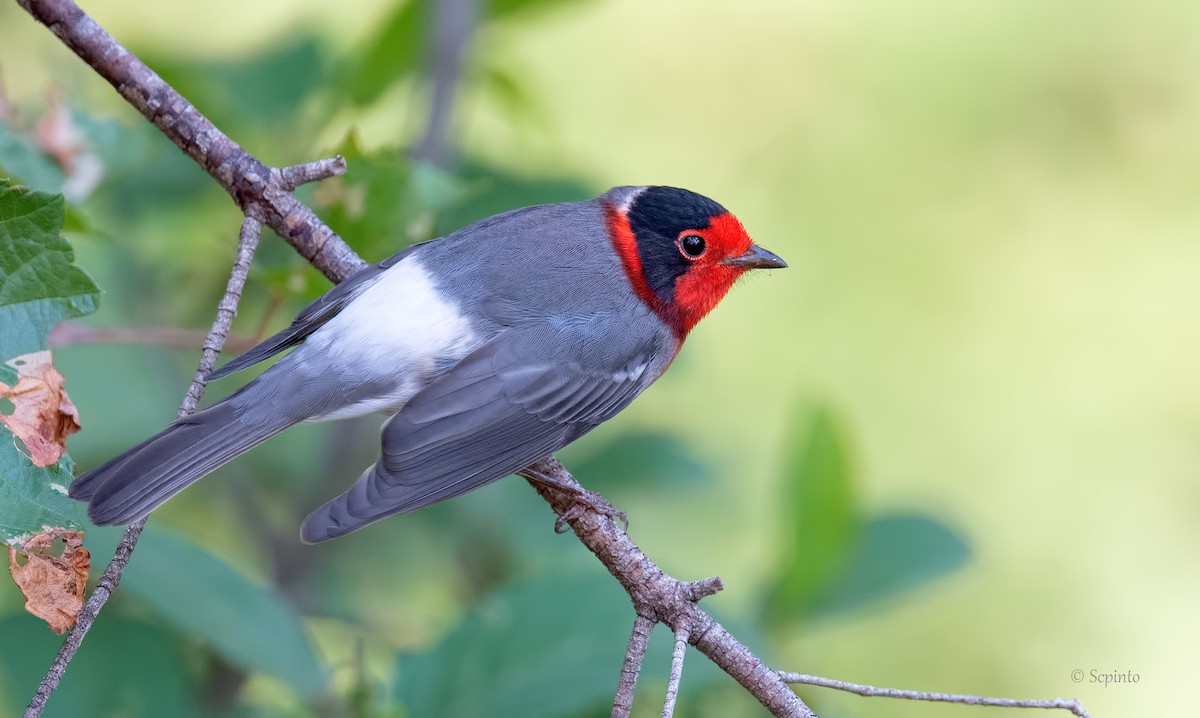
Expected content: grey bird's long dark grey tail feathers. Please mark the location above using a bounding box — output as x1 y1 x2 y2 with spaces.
68 387 295 526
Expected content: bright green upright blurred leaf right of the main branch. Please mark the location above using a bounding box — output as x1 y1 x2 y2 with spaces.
768 408 860 621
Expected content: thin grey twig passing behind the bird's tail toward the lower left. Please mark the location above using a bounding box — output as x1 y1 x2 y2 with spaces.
24 213 263 718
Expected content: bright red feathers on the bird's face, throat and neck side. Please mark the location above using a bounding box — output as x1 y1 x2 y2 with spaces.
605 204 751 342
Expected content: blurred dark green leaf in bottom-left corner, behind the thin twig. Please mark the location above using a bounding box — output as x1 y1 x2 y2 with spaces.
0 611 200 718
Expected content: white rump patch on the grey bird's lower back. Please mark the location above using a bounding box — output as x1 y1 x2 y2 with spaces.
305 255 480 420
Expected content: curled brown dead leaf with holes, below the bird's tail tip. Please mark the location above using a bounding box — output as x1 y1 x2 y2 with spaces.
8 528 91 634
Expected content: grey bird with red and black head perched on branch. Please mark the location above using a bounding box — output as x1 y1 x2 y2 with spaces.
68 186 787 543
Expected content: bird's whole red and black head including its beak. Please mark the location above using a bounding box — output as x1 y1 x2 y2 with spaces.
605 187 787 341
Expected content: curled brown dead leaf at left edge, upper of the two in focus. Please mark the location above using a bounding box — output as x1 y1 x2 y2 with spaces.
0 351 79 466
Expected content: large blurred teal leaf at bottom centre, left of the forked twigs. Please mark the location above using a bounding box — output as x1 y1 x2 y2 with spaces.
396 574 638 718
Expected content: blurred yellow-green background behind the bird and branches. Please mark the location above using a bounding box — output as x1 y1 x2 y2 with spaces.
0 0 1200 717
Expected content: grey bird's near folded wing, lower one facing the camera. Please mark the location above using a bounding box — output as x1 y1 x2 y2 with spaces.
301 327 673 543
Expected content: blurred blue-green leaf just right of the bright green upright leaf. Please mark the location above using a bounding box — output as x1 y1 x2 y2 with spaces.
810 513 971 616
